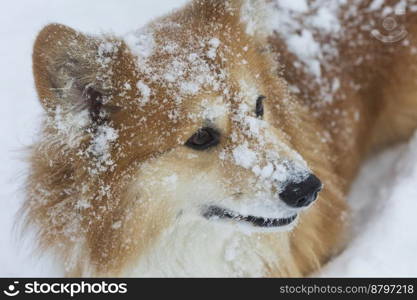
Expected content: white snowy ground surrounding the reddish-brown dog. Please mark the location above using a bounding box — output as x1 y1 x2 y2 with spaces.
0 0 417 277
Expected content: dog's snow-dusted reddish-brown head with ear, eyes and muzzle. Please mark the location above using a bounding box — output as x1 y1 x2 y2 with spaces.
30 1 332 276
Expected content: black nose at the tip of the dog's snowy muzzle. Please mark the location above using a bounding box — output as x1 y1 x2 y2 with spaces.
279 174 323 208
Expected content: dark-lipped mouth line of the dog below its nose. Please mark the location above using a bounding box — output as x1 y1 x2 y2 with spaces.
203 206 297 228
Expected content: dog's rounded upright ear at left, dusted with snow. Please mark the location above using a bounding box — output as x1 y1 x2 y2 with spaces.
33 24 119 122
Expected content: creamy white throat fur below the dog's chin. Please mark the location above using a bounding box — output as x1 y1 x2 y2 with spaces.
127 218 288 277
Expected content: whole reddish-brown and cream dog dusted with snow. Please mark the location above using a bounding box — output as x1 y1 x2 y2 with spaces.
22 0 417 276
